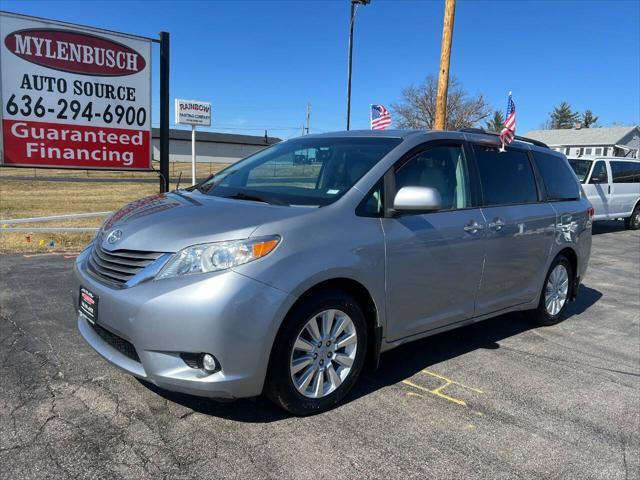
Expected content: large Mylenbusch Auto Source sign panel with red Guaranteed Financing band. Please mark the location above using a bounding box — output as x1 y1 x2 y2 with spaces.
0 13 151 170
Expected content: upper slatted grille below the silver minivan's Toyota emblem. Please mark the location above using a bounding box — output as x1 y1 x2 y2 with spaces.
88 241 162 287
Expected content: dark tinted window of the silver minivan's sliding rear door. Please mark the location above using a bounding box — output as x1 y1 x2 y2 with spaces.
473 145 538 206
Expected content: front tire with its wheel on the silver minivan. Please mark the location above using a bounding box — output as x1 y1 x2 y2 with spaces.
265 289 368 416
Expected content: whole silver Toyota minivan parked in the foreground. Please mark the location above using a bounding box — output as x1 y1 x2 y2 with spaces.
74 131 593 415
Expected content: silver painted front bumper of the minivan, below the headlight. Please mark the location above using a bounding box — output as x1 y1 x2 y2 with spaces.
73 248 295 398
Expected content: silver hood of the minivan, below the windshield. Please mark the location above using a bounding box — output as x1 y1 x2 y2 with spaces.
98 191 309 253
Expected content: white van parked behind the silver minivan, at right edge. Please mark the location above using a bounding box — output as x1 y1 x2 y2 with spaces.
568 156 640 230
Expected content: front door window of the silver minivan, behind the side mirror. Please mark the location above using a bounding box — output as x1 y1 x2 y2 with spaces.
396 146 471 210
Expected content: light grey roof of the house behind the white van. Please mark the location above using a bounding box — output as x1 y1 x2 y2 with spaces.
525 125 640 146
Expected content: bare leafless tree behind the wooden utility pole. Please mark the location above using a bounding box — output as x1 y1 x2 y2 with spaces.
391 75 491 130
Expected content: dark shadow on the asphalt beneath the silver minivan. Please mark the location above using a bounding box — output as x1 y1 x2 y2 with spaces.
140 285 602 423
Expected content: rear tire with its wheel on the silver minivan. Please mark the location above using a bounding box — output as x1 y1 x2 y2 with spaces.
529 255 574 326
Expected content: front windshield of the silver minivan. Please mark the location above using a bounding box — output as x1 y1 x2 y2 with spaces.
195 137 402 207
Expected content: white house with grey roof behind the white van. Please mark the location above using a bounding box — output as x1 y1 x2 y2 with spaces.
525 125 640 158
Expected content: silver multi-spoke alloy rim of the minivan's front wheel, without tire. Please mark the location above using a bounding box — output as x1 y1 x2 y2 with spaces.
289 309 358 398
